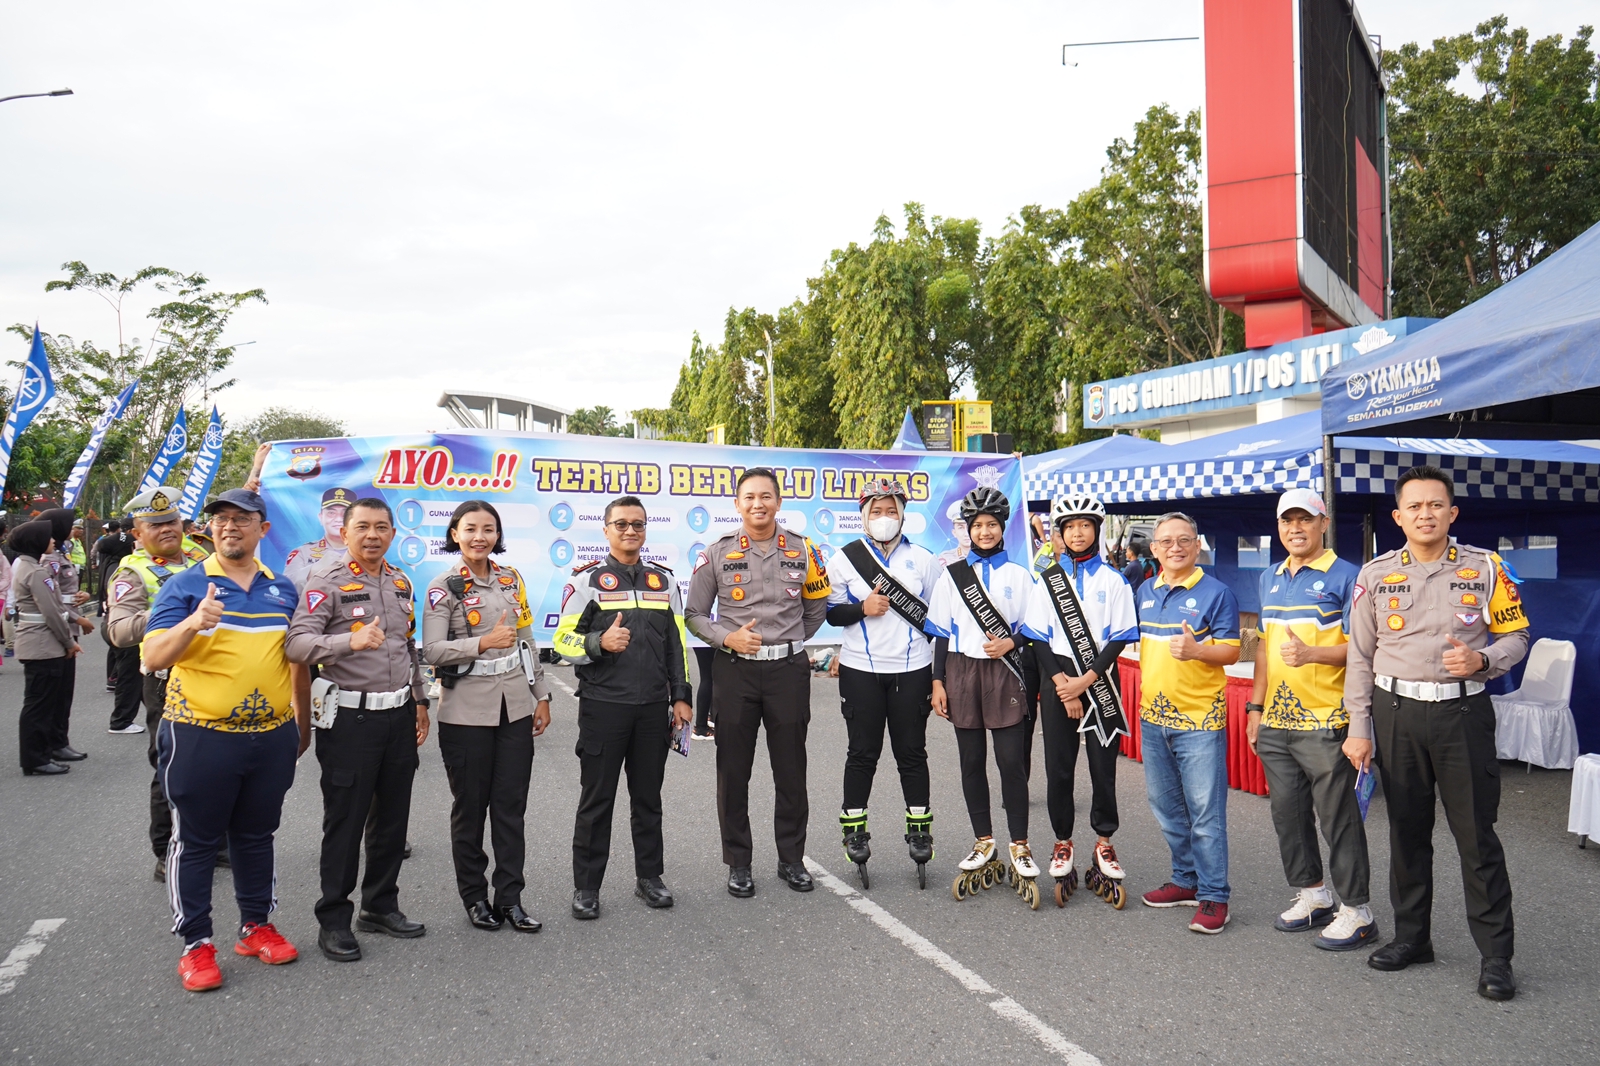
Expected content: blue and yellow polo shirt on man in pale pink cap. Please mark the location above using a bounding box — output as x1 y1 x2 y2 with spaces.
1258 549 1360 730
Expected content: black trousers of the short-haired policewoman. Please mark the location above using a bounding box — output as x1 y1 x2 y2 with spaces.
438 699 533 909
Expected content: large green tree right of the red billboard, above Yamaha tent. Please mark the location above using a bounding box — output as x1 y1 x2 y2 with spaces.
1384 16 1600 317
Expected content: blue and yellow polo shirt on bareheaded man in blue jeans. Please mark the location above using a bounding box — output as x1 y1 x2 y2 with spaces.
1138 567 1238 730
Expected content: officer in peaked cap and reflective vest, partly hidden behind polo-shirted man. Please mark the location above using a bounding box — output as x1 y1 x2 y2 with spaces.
106 488 208 880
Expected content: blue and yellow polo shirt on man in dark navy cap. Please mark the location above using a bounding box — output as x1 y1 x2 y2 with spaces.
144 555 298 733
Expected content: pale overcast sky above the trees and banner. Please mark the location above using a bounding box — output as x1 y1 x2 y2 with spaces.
0 0 1574 434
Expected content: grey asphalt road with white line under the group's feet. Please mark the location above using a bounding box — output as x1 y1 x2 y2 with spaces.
0 637 1600 1066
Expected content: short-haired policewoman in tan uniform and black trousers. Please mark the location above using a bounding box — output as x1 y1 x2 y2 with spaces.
422 499 550 933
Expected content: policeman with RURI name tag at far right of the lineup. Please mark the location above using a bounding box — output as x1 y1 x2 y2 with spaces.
1344 466 1528 999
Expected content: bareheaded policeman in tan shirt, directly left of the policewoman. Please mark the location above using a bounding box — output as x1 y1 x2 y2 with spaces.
286 498 429 962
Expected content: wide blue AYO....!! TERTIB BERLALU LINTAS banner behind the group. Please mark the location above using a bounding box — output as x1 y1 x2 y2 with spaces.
251 432 1032 643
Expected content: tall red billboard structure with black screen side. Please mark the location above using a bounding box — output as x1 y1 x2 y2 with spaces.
1202 0 1389 347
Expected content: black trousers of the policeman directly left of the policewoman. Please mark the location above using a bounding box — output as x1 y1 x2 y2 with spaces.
317 699 418 928
